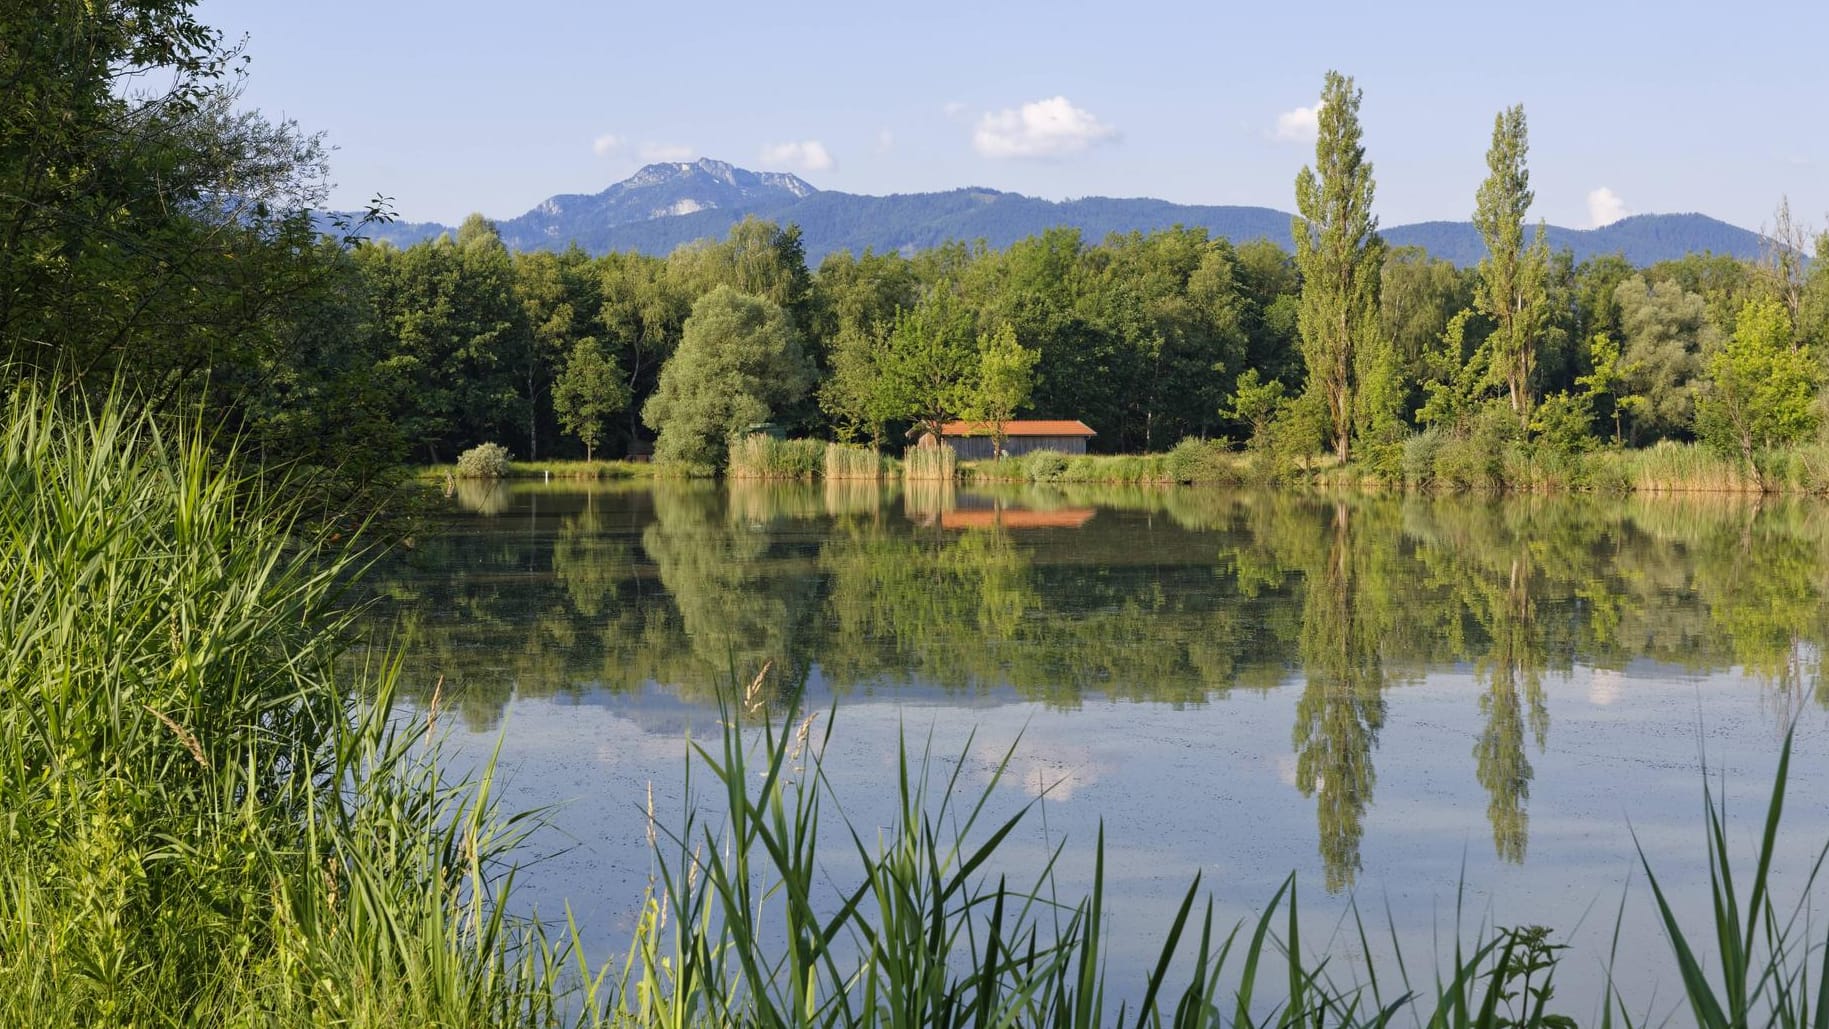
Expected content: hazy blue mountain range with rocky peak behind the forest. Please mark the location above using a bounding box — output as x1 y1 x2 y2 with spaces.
345 159 1761 267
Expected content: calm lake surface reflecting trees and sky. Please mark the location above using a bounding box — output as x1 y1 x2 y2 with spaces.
375 483 1829 1022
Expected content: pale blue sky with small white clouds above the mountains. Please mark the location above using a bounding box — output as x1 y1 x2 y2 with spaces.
199 0 1829 228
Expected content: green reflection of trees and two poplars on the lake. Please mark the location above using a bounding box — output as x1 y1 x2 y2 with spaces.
380 483 1829 890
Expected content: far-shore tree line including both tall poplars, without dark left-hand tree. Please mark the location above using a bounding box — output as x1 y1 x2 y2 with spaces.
336 73 1829 473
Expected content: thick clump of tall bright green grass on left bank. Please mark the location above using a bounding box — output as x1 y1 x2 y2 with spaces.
0 389 552 1027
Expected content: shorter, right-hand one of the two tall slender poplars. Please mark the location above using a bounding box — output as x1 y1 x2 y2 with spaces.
1474 104 1549 428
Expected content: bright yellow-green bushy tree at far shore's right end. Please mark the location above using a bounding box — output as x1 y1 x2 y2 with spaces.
1695 298 1822 464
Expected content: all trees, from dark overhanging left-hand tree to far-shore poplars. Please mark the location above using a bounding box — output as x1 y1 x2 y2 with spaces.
0 9 1829 483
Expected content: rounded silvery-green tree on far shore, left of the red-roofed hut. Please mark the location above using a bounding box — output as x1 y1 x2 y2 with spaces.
642 285 812 468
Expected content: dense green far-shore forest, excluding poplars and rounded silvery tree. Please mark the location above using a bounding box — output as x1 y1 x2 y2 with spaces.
353 190 1829 482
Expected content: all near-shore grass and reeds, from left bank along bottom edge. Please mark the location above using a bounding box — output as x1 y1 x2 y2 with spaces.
0 389 1829 1029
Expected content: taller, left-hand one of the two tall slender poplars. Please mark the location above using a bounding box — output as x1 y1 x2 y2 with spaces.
1291 71 1388 461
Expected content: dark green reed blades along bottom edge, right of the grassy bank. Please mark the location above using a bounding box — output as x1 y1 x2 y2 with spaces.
587 678 1829 1029
